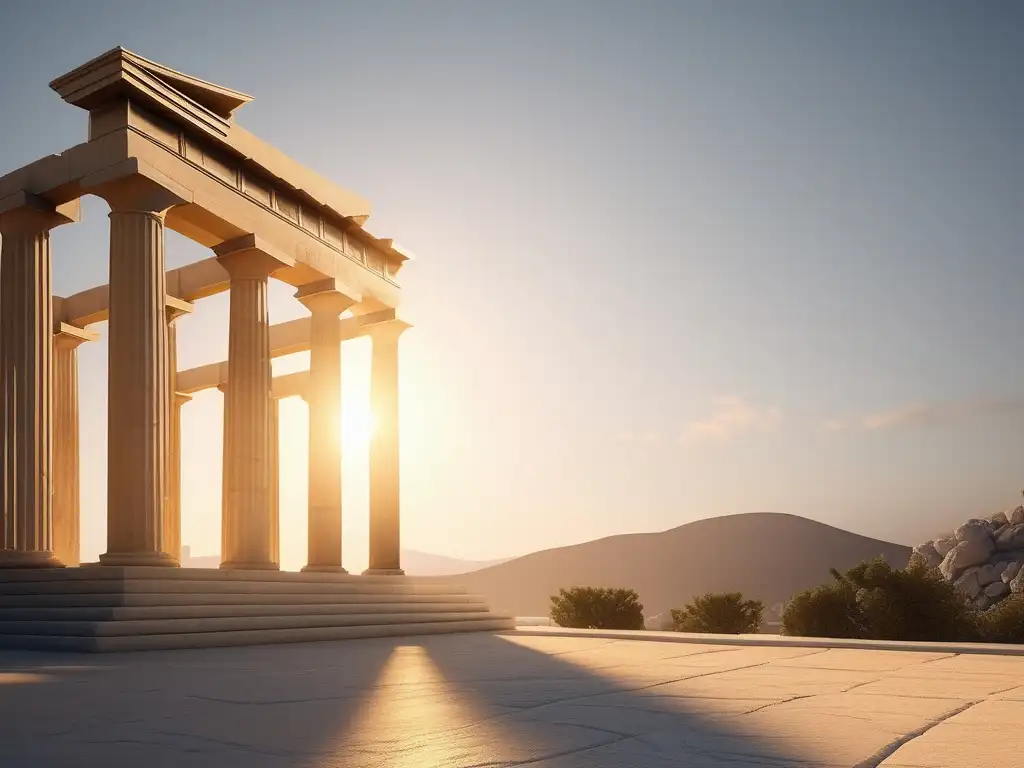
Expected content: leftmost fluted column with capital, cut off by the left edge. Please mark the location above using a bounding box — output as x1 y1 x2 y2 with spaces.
0 191 78 567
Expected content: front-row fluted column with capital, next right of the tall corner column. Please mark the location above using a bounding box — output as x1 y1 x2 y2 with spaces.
214 234 295 569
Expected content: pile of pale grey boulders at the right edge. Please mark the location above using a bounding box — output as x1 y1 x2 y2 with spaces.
913 507 1024 610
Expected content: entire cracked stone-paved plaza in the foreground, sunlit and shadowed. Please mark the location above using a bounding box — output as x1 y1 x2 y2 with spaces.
0 633 1024 768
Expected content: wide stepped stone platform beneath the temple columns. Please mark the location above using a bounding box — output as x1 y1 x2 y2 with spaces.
0 565 513 652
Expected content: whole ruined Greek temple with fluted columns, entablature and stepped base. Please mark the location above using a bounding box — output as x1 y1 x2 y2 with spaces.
0 48 507 650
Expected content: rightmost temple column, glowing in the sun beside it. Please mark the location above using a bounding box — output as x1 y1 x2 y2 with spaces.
366 321 409 575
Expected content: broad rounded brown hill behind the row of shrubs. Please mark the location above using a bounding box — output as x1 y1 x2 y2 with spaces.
450 513 910 618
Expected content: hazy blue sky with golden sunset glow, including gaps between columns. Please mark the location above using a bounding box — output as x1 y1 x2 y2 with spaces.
0 0 1024 568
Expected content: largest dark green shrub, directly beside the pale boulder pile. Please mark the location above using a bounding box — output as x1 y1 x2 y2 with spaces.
782 557 978 642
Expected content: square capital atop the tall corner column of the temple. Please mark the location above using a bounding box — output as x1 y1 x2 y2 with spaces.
82 158 193 216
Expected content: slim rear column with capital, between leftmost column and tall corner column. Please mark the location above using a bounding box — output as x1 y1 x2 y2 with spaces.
53 323 99 565
